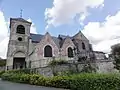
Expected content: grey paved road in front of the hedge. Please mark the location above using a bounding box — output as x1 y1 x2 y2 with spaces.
0 81 66 90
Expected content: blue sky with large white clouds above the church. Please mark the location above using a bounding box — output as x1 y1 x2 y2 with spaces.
0 0 120 58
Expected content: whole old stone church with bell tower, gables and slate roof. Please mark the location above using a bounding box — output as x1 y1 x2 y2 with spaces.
7 18 105 69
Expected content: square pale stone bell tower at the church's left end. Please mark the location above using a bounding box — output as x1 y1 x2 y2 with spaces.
6 18 32 69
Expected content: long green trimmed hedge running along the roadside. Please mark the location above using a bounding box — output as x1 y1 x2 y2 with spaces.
2 71 120 90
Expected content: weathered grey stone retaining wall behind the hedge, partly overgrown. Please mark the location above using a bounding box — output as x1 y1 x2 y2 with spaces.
31 61 117 76
